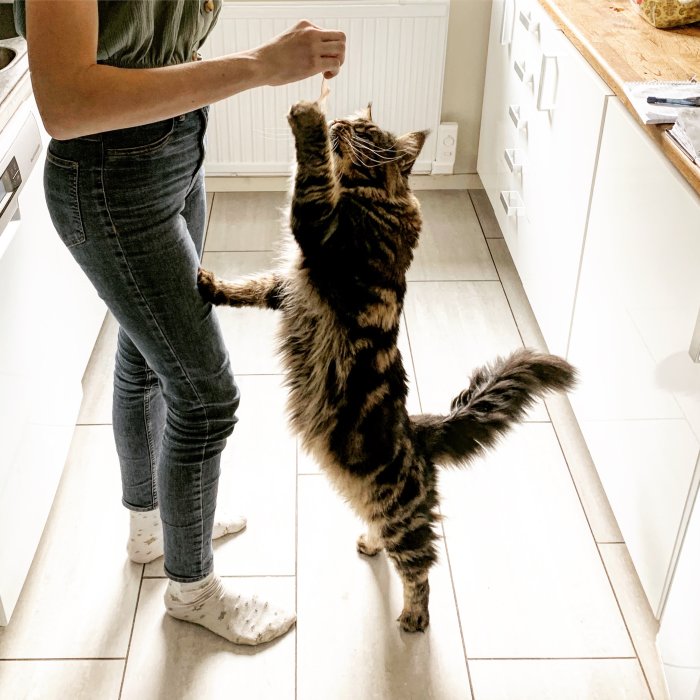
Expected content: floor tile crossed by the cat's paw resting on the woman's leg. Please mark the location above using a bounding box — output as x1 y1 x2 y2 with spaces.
202 251 282 375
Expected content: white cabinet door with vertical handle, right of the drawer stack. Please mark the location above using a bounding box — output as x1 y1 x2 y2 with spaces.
513 9 612 355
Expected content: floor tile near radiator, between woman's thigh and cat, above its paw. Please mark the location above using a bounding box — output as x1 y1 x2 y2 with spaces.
204 192 288 251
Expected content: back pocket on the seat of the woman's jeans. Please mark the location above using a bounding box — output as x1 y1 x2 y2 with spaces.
44 150 85 248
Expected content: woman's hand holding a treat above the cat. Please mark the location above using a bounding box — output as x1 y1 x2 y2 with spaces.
251 20 345 85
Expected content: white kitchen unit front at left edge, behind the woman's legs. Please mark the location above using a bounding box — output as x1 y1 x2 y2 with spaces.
0 98 106 626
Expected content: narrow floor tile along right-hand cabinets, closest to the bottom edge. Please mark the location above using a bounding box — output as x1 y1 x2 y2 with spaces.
599 544 669 700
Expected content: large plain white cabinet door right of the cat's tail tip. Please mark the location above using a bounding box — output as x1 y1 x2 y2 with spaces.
569 98 700 615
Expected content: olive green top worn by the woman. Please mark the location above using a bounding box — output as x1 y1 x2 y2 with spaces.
14 0 222 68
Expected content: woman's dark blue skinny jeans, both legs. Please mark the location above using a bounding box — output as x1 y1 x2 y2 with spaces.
44 109 239 582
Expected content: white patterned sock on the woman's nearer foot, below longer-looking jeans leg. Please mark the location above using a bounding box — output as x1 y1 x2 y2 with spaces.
163 573 296 645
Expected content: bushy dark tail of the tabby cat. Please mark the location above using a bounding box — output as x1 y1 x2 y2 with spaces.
411 349 576 466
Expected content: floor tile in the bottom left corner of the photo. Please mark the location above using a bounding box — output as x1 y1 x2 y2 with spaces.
0 659 124 700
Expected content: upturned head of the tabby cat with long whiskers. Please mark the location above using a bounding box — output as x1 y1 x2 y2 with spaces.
330 105 430 193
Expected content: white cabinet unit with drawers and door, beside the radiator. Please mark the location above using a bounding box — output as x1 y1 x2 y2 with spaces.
478 0 612 355
